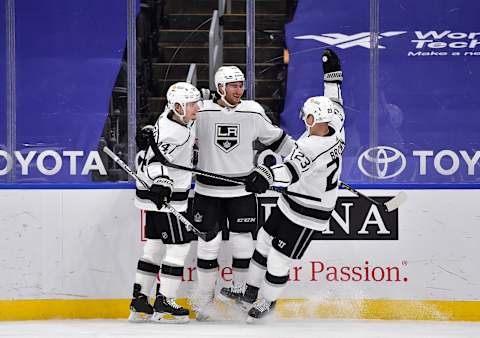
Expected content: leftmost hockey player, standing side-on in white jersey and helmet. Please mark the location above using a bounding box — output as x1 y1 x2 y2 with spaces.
129 82 201 323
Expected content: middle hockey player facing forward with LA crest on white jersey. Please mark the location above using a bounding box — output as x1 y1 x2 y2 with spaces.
192 66 294 320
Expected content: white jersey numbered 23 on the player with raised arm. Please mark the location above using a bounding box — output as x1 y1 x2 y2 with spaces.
272 104 345 231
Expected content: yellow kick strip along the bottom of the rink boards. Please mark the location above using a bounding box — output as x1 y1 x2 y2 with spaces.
0 299 480 321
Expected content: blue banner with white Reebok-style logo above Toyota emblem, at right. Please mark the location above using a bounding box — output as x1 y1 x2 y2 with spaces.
281 0 480 184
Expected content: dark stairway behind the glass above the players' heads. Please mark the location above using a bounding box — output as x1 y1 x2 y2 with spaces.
148 0 288 124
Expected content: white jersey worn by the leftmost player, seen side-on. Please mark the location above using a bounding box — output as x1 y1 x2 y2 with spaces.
135 112 195 212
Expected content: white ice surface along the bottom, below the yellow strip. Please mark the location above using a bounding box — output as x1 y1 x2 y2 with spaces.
0 320 480 338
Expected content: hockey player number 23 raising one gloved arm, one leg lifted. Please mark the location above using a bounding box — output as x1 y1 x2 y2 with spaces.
221 49 345 322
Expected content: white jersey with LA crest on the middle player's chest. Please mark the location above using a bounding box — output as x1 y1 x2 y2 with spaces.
195 100 294 197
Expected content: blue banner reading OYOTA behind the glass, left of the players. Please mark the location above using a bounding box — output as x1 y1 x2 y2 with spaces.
0 0 128 183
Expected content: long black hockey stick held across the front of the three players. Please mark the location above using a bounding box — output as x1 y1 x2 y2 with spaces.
141 130 322 202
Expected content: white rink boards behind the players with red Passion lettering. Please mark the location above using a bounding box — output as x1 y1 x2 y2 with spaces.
0 189 480 300
